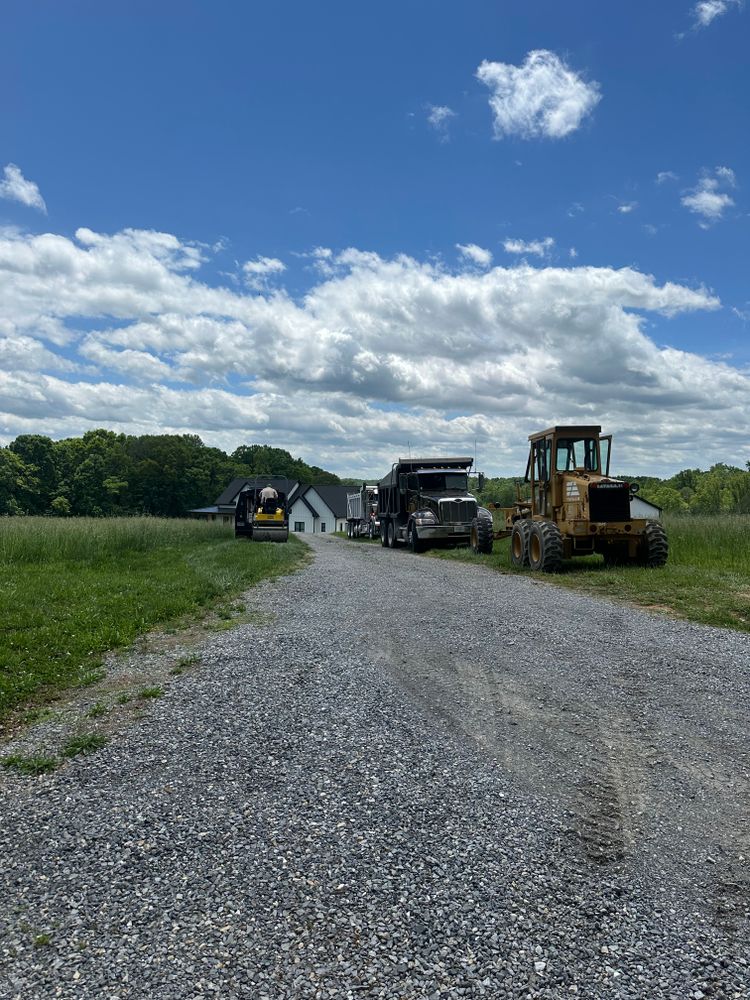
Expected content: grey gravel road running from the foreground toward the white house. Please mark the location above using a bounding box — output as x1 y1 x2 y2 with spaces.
0 536 750 1000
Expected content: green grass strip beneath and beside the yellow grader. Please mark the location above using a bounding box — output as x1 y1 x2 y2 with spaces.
433 514 750 632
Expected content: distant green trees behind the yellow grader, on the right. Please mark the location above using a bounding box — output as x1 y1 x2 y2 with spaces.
473 462 750 514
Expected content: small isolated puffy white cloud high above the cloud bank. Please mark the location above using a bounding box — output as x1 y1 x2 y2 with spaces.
476 49 601 139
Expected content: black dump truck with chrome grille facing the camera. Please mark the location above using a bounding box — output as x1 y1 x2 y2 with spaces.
378 458 477 552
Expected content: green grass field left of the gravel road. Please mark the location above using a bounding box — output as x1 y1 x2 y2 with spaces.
0 517 307 719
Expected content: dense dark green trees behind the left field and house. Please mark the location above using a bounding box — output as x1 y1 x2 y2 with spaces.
0 429 340 517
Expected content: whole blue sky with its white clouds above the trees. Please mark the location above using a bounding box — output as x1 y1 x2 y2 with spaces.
0 0 750 475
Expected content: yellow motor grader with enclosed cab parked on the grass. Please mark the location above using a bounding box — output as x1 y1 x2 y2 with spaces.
471 425 669 573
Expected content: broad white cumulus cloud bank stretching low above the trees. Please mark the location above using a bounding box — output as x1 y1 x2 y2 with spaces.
0 230 750 476
